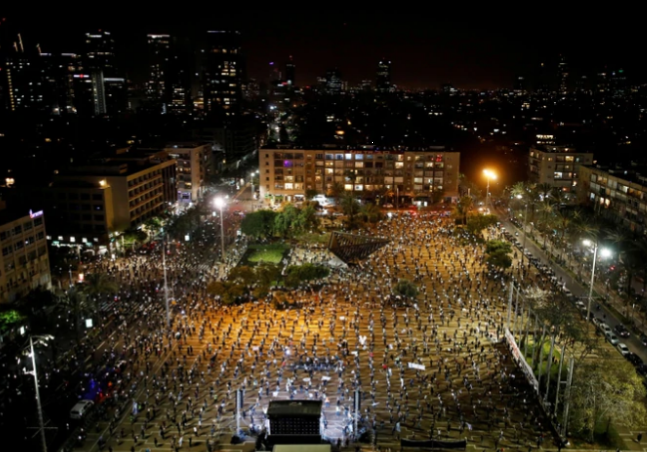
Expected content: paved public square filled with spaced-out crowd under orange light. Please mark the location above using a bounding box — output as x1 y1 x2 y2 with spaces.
71 214 554 451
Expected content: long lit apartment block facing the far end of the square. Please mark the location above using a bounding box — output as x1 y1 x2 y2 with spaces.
259 146 460 202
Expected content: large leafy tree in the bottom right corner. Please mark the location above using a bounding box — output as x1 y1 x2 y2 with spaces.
570 357 647 442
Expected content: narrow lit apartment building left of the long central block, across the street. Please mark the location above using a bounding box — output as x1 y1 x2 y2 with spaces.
164 142 212 204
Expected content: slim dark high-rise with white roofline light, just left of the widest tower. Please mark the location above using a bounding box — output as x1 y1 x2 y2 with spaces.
146 35 171 113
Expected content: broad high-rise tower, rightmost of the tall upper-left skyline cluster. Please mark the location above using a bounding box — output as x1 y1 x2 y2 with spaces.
202 31 244 117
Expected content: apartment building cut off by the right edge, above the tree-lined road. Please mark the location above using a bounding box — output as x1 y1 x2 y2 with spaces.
578 166 647 234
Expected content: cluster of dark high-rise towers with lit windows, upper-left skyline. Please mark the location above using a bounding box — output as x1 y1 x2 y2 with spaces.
0 25 245 118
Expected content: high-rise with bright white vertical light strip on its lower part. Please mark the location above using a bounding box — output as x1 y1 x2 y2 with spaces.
84 30 127 115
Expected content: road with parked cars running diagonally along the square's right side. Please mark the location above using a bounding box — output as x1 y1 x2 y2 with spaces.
495 207 647 362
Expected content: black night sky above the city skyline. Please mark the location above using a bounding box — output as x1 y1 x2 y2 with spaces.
4 10 647 89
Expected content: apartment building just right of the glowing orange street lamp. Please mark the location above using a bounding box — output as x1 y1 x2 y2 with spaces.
528 145 593 201
